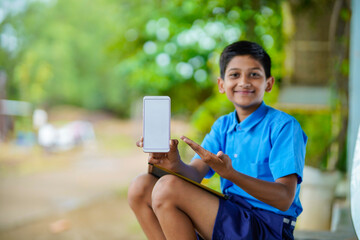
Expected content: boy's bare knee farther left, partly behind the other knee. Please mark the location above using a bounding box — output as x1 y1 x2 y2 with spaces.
128 174 156 207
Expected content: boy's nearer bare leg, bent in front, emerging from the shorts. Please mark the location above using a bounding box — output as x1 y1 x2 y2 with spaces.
152 175 219 240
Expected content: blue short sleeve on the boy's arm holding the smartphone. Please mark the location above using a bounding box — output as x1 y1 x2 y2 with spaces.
192 119 222 178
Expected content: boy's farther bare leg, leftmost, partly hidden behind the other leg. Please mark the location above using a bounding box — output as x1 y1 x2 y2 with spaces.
128 174 165 240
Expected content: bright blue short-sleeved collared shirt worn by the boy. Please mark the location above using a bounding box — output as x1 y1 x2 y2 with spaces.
193 102 307 217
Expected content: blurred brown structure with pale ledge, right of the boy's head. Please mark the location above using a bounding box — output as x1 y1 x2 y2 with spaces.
279 0 337 109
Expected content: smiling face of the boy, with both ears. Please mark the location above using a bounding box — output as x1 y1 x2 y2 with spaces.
218 55 274 112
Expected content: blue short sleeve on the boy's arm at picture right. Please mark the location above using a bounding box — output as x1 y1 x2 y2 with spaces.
269 119 307 183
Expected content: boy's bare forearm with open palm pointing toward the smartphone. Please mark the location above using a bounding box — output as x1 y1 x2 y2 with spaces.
181 137 297 211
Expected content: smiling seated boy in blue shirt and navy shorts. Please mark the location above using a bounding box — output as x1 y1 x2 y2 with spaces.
128 41 307 240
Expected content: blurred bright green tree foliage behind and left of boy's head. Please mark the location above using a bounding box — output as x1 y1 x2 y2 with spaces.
0 0 283 116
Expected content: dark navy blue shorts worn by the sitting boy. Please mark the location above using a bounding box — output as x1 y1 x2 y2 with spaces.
200 195 296 240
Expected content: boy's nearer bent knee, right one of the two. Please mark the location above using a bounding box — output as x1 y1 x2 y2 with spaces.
151 175 182 211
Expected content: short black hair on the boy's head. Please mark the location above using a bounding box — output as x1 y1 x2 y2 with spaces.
220 41 271 79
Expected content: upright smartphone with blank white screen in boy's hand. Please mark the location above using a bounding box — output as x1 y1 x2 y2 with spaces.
143 96 171 153
